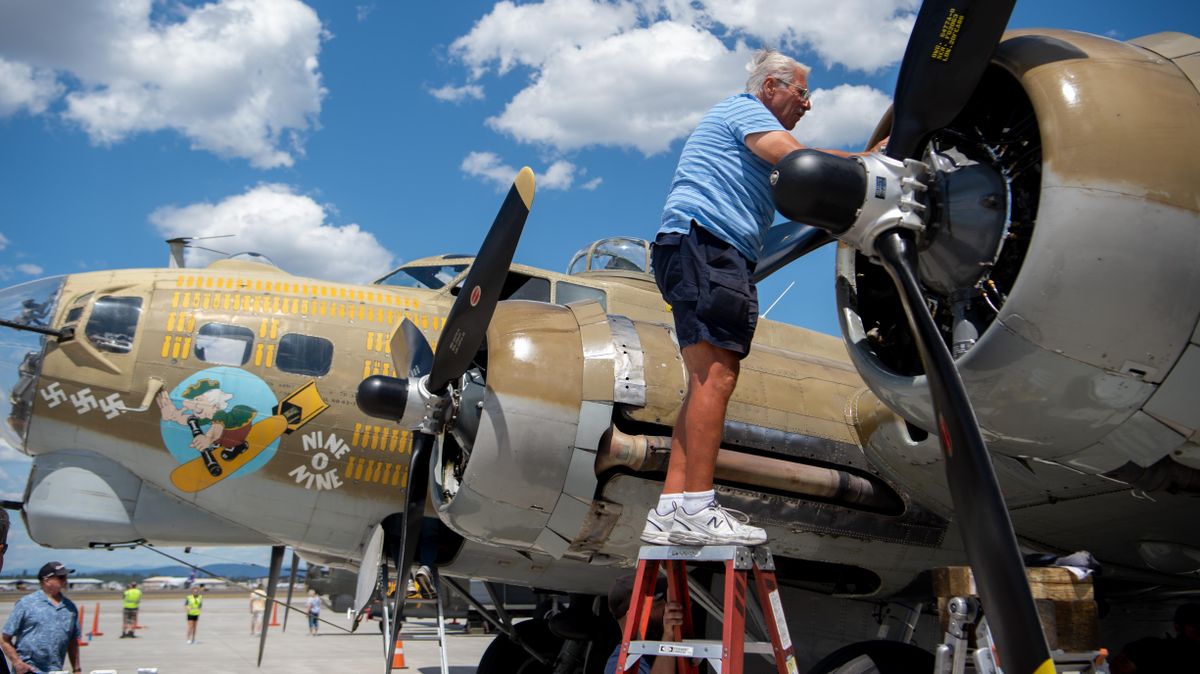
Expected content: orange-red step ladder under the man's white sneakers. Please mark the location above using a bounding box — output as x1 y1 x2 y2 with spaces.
617 546 797 674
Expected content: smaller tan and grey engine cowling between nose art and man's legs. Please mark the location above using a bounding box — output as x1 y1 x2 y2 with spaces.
431 301 616 558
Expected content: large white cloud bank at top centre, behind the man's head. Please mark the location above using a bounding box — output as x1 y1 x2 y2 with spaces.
450 0 918 156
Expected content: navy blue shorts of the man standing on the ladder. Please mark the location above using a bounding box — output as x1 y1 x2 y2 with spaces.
650 221 758 359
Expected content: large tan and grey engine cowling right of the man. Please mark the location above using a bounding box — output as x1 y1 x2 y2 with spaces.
838 31 1200 473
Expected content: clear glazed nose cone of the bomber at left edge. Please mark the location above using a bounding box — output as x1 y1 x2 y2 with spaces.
0 276 66 450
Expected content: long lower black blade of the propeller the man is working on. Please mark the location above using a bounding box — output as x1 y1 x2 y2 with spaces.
875 230 1054 674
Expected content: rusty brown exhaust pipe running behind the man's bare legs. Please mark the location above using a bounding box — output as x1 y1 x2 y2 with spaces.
595 427 904 512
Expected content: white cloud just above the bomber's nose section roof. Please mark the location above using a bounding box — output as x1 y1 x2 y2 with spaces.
150 185 395 283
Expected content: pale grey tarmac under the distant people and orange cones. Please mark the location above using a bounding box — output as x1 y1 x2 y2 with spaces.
0 592 493 674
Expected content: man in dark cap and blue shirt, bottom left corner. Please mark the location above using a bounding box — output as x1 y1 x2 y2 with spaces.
0 561 80 674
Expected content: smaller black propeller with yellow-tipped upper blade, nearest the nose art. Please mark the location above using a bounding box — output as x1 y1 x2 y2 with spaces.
358 167 535 664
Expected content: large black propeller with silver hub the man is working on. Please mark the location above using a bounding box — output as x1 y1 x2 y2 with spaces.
772 0 1054 674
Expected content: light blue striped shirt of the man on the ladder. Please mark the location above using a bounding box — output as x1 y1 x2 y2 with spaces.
659 94 787 263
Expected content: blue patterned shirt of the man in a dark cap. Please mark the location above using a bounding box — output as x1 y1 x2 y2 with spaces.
4 590 79 672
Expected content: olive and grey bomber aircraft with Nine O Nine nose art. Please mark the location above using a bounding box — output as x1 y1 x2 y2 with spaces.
0 2 1200 674
